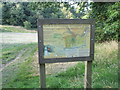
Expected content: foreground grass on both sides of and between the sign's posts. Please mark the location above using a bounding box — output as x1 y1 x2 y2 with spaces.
3 41 118 88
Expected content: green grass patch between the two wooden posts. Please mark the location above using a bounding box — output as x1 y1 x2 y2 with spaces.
47 63 84 88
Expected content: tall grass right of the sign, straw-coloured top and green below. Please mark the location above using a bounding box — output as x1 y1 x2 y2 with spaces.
93 41 118 88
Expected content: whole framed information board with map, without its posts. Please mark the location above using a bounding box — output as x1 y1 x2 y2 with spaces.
38 19 94 63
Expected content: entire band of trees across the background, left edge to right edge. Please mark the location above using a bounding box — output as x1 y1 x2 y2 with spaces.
2 2 120 42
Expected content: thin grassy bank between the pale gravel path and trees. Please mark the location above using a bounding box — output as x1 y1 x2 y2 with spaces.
0 25 36 33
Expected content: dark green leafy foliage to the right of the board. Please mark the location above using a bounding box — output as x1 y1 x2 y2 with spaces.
91 2 120 42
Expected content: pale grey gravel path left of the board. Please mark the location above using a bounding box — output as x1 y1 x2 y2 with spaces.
0 32 37 43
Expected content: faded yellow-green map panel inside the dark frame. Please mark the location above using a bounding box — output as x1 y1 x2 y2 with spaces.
43 24 90 58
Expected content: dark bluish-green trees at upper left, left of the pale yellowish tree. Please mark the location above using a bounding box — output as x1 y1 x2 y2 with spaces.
2 2 65 28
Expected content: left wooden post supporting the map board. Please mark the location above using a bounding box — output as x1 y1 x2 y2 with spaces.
40 64 46 88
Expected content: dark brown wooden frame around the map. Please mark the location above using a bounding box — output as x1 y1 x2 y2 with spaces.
37 19 95 64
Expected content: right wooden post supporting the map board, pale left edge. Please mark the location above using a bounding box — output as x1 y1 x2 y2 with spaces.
84 61 92 90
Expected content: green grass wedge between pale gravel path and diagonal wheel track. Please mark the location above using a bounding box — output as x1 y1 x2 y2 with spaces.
0 44 34 64
